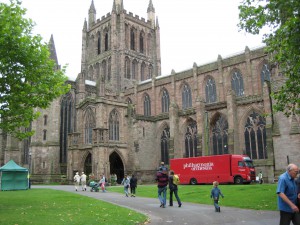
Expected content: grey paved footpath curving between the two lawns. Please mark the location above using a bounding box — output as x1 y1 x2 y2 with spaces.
32 185 279 225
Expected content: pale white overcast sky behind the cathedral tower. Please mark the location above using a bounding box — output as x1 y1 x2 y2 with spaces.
6 0 263 80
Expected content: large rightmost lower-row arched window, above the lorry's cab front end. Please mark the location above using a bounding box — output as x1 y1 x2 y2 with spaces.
244 112 268 159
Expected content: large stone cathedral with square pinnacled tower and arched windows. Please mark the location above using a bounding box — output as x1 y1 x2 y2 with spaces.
0 0 300 183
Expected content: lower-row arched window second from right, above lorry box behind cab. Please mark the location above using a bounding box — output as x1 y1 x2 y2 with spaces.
210 115 228 155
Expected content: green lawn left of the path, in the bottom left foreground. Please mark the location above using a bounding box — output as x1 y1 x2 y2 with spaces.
0 189 147 225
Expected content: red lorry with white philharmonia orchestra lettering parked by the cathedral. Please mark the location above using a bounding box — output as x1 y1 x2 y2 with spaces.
170 154 255 184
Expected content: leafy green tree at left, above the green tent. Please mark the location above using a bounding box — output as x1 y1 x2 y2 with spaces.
0 0 69 139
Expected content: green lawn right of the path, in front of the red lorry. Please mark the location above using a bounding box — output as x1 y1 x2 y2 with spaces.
108 184 277 210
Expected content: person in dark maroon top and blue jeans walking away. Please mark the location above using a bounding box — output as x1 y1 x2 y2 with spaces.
155 167 169 208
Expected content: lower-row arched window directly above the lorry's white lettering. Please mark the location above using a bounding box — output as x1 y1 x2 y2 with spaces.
184 121 199 158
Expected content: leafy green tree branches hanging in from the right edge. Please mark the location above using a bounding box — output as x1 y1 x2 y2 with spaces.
238 0 300 116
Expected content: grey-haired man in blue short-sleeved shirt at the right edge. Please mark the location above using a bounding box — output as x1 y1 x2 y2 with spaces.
276 164 300 225
